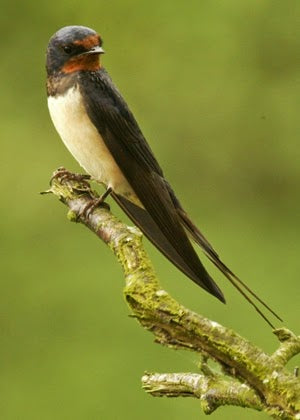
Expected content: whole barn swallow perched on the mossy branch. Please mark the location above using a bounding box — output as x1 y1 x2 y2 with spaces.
46 26 281 327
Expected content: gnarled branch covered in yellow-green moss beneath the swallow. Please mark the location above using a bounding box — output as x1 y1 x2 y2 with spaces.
46 168 300 419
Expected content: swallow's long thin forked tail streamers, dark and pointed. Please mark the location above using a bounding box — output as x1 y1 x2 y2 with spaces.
176 207 282 329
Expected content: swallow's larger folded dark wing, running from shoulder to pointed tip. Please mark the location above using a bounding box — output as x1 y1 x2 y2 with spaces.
80 70 225 302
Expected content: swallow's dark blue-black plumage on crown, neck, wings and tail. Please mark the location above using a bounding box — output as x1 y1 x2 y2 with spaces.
47 26 280 326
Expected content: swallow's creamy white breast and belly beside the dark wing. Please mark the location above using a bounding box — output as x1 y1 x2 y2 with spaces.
48 87 134 196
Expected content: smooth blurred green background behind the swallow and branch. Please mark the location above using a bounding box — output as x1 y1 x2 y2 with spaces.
0 0 300 420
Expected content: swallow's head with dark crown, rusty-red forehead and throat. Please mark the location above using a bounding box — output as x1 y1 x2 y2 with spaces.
46 26 104 76
